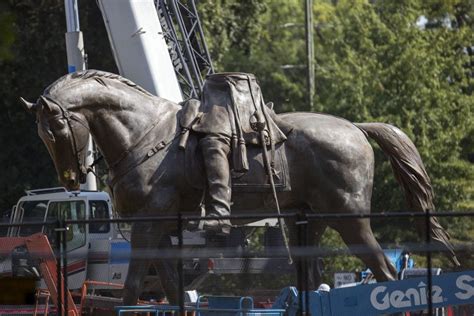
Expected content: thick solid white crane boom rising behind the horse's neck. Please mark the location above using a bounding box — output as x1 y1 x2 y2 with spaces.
98 0 183 102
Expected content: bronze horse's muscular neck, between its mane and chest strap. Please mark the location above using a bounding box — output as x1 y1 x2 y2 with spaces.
68 87 171 164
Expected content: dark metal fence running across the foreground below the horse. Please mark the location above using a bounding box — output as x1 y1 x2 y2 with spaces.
0 209 474 315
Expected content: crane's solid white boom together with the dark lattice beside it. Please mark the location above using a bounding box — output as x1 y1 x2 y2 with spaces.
98 0 214 102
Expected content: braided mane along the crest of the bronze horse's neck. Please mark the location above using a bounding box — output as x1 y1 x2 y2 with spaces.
43 69 153 96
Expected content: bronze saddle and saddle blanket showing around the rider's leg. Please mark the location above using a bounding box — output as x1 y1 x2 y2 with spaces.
179 99 293 192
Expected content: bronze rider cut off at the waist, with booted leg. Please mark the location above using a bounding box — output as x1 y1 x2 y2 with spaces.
192 73 285 234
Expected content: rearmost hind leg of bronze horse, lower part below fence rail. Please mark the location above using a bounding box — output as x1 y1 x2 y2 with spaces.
331 218 397 282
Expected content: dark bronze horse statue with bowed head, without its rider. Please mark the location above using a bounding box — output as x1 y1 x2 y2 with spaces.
23 70 457 305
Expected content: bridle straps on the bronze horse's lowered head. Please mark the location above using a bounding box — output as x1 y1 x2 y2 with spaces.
40 96 90 183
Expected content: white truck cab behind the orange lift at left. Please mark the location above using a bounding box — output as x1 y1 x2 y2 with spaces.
0 188 130 289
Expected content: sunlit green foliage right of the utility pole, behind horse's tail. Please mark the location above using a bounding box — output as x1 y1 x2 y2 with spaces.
315 1 474 270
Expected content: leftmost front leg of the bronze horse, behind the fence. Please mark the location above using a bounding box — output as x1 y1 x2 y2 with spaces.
123 223 152 305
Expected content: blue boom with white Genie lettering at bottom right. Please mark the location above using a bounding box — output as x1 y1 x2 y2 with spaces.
266 270 474 316
